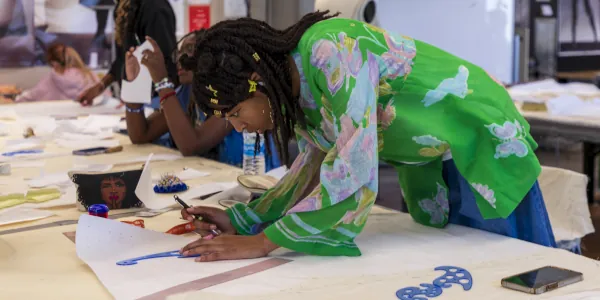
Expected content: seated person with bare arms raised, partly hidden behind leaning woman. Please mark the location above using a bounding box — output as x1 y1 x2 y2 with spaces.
125 31 281 171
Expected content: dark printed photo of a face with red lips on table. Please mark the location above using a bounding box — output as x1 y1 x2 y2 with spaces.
71 170 144 210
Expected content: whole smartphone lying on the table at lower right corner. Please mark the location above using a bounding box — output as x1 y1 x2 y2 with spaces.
502 266 583 295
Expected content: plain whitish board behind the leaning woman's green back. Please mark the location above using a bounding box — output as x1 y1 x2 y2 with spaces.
377 0 515 83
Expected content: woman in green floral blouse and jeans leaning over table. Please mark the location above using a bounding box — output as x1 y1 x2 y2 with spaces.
173 12 556 262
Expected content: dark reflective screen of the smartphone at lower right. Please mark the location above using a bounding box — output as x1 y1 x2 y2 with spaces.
504 267 582 289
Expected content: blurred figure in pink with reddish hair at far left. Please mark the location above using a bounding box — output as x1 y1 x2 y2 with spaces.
15 44 99 102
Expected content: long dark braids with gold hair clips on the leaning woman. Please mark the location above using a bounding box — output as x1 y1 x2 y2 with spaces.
180 11 338 166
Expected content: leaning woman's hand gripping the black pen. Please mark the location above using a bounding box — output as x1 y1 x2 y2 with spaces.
181 206 237 236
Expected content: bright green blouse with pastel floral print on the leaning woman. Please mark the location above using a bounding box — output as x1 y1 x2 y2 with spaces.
228 18 541 256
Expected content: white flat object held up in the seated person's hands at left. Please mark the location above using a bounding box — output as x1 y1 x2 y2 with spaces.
121 41 154 104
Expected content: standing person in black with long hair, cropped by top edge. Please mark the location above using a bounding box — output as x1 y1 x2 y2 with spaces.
77 0 178 105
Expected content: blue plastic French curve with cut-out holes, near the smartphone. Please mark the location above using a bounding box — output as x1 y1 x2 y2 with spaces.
396 266 473 300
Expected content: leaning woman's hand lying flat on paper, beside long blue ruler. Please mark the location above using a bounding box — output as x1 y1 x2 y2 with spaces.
181 233 279 262
